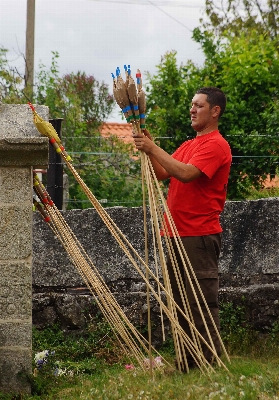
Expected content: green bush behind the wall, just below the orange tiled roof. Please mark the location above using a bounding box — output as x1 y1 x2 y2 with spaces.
69 136 142 208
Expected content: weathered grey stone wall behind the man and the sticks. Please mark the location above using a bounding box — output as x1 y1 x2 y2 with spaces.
33 198 279 341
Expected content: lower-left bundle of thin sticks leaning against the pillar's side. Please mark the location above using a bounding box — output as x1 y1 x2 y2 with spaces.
33 173 171 370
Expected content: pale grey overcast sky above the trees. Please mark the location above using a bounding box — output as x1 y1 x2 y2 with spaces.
0 0 204 122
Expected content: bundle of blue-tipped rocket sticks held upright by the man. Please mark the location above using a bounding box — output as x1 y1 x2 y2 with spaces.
110 66 229 370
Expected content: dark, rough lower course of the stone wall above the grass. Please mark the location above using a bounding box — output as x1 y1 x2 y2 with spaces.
33 284 279 343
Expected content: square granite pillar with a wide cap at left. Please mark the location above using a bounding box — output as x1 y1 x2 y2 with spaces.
0 104 48 393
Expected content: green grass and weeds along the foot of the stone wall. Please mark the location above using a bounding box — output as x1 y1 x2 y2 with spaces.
0 303 279 400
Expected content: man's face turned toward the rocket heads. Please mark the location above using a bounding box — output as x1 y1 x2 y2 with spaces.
190 93 216 132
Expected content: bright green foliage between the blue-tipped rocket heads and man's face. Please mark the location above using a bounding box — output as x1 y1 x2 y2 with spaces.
146 52 199 152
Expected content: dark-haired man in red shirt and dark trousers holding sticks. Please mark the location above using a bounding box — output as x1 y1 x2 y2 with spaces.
133 87 232 369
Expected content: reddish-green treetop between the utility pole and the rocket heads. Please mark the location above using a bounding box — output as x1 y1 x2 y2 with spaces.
35 52 114 127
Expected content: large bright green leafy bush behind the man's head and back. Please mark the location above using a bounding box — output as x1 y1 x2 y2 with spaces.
197 31 279 199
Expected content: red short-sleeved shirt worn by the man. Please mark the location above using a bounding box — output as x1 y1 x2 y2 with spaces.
163 130 232 236
